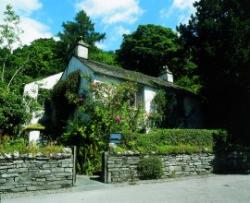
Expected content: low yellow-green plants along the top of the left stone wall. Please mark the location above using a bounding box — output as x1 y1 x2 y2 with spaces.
0 136 63 154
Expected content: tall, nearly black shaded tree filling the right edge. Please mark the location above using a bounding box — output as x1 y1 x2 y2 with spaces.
178 0 250 143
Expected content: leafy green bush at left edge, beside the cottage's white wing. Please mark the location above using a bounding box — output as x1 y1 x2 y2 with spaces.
0 84 30 135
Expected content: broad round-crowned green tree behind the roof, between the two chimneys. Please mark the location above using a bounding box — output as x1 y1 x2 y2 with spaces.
117 24 179 76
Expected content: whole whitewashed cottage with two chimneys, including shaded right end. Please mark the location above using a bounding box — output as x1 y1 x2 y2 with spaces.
24 41 203 141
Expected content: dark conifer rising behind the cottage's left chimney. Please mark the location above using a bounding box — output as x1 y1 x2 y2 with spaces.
58 11 105 60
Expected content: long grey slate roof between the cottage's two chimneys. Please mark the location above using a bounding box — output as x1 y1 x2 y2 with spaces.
76 57 183 89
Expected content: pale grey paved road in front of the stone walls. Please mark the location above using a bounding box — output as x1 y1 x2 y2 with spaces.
2 175 250 203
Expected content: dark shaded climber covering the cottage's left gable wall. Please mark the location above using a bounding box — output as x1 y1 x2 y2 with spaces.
41 71 81 139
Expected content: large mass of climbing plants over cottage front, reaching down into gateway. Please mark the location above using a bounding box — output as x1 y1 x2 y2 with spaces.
46 72 145 174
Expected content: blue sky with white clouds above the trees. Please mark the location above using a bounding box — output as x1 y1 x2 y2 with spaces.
0 0 195 50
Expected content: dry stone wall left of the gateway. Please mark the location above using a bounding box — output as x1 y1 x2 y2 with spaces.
0 150 73 193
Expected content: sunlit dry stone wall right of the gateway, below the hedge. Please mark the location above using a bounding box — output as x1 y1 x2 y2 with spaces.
103 153 214 183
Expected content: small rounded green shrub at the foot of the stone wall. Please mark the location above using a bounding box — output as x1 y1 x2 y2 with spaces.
138 157 163 180
